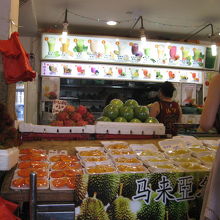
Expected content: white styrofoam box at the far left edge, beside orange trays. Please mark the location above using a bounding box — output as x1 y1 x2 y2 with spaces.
0 147 19 170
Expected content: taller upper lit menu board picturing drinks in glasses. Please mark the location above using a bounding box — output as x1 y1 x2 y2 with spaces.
42 33 210 68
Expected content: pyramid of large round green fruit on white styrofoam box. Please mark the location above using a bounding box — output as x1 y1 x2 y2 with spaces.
97 99 158 123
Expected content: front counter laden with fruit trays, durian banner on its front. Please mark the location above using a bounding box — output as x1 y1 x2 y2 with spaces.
1 136 215 220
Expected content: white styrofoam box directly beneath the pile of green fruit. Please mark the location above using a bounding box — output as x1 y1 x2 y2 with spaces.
96 121 165 135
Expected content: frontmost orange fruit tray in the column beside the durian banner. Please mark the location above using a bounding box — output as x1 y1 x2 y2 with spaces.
50 177 76 190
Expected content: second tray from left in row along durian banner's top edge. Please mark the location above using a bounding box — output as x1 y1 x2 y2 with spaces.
116 164 149 173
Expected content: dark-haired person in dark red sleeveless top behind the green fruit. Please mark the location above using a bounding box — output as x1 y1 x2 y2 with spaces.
150 81 182 134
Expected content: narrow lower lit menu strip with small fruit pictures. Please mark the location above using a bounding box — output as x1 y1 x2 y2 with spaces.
41 61 204 84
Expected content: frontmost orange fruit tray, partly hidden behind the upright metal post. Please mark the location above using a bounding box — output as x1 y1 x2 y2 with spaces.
10 176 49 190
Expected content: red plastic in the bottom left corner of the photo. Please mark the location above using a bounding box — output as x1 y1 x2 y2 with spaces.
0 197 20 220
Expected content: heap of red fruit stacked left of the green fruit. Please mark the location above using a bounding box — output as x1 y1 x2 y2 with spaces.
50 105 95 126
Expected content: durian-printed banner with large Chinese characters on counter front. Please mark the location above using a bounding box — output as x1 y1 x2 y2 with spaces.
74 172 209 220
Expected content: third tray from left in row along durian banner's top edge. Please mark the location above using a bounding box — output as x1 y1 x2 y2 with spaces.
148 163 183 173
